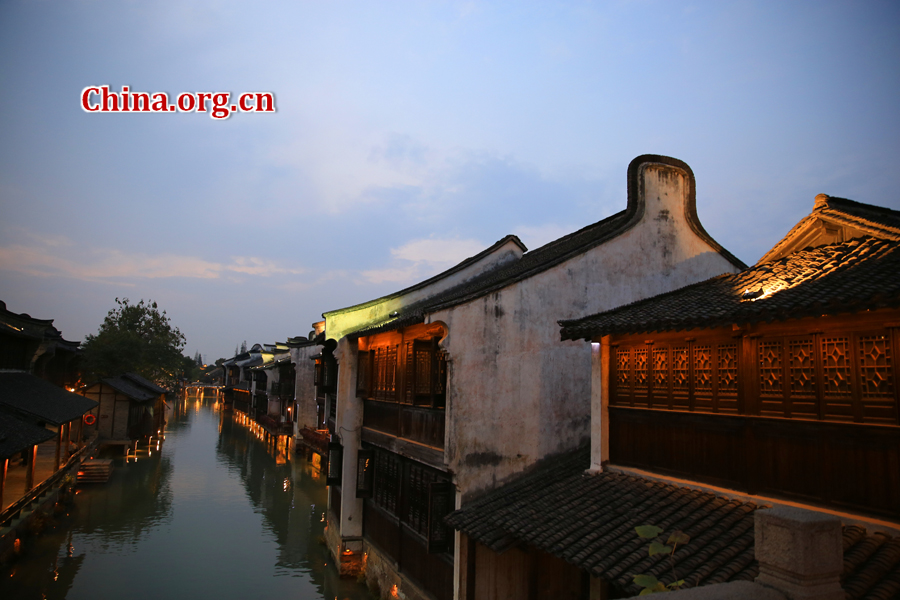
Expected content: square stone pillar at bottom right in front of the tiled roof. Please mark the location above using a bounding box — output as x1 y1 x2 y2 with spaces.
755 506 845 600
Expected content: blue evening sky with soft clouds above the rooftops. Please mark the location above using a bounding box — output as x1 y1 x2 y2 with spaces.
0 0 900 362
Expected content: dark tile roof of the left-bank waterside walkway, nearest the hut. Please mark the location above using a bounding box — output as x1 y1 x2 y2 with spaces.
0 371 97 425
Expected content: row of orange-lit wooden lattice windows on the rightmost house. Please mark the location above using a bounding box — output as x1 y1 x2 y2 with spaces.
609 329 900 425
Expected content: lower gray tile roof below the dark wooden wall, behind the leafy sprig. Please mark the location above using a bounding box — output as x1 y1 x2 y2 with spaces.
446 448 900 600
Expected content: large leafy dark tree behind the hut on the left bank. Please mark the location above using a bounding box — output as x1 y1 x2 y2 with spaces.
82 298 190 386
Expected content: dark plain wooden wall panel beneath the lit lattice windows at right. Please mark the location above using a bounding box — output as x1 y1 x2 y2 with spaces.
609 407 900 519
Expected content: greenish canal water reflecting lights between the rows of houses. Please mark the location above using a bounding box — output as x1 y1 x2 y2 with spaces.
0 397 371 600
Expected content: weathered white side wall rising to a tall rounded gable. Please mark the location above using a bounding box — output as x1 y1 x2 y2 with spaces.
429 163 737 501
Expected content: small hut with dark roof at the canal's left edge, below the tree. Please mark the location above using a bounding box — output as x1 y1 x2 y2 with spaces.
79 373 167 445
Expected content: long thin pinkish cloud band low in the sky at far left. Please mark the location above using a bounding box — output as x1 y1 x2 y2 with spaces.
0 232 304 281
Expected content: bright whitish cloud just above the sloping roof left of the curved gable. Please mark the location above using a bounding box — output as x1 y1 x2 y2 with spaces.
362 238 487 284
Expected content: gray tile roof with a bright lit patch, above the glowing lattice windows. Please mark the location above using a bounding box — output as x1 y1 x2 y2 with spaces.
560 237 900 340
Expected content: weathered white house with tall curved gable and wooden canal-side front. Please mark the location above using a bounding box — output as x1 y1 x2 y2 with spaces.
322 155 744 600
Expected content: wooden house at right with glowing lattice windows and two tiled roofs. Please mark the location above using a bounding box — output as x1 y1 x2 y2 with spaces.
448 195 900 600
